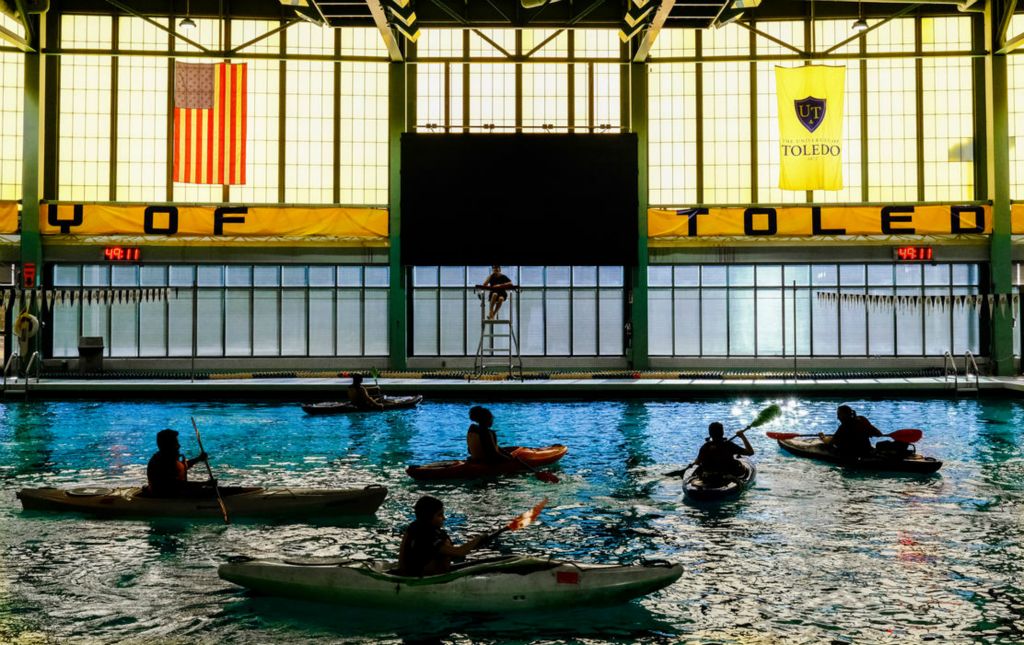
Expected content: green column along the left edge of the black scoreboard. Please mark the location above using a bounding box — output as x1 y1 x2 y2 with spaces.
387 61 409 370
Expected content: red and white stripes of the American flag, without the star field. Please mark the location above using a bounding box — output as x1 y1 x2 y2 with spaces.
173 62 248 184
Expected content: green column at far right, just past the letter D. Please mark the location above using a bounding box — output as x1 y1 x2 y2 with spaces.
985 0 1014 376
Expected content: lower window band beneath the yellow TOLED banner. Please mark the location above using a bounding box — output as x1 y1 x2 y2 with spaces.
648 264 980 357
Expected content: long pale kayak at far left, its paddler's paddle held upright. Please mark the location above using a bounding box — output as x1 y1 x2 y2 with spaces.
17 485 387 518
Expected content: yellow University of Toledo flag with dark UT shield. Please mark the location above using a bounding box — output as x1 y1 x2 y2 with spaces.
775 65 846 190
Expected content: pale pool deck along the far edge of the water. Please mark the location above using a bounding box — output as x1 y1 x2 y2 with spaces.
3 377 1024 400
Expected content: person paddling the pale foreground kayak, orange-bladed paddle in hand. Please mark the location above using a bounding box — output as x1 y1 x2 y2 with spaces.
398 495 492 576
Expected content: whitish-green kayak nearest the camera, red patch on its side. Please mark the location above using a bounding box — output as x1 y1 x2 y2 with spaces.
217 556 683 613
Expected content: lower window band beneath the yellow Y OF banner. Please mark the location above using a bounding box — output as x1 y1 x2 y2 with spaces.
53 264 388 357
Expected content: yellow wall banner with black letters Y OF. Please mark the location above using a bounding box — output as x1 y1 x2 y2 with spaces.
39 204 388 242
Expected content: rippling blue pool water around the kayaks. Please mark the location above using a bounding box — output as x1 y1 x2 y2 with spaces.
0 398 1024 644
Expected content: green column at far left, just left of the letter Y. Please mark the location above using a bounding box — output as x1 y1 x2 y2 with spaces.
20 15 45 367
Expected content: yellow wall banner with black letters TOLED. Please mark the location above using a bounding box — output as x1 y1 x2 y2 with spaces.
647 204 991 241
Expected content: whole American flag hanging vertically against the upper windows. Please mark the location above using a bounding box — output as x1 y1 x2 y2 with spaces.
174 61 248 184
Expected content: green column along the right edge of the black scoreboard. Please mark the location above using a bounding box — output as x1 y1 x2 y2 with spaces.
629 62 650 370
